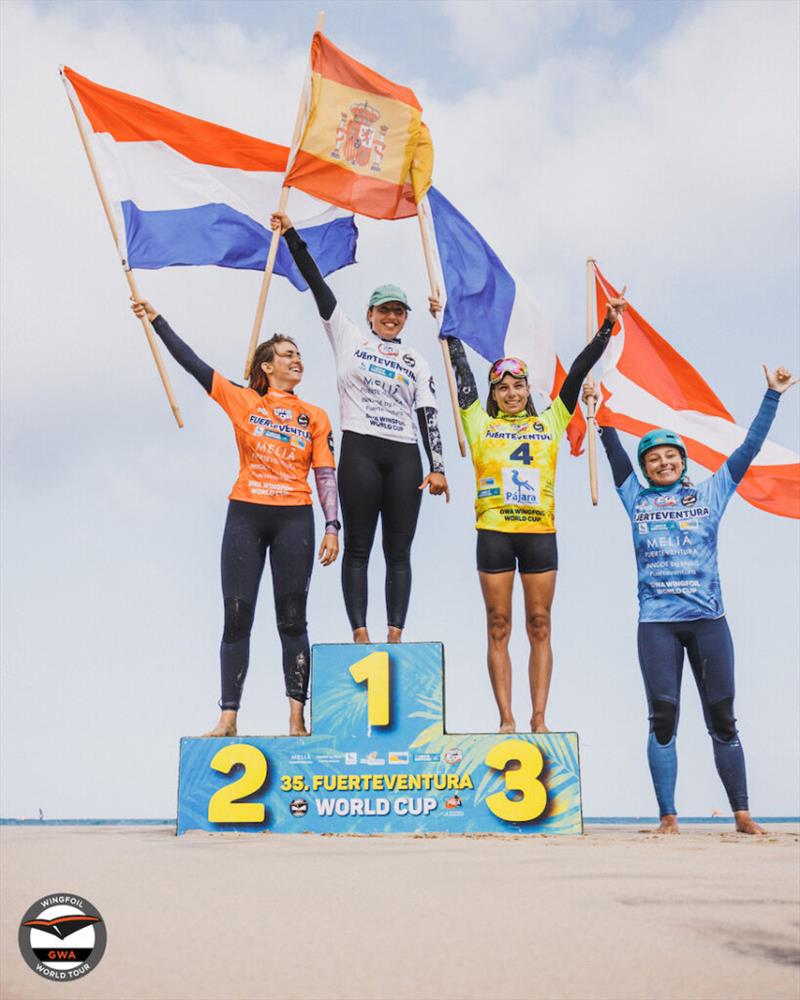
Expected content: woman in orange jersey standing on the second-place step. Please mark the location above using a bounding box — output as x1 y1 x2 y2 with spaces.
132 300 341 736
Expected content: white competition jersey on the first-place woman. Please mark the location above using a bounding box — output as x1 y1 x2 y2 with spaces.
322 303 436 444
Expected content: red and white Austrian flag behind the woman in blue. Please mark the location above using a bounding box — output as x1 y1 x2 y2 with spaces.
594 265 800 518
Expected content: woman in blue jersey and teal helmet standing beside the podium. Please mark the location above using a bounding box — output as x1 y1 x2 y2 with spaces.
583 366 798 833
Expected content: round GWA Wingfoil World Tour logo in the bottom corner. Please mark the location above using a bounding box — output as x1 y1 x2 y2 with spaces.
18 892 106 982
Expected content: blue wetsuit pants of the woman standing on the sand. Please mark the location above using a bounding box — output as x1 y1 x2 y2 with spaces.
638 617 748 816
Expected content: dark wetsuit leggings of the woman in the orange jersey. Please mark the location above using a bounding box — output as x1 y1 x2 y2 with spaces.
219 500 314 709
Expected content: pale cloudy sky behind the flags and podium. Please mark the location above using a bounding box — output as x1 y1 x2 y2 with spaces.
0 0 800 817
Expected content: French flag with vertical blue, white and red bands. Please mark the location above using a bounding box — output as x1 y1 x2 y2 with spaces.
425 187 586 455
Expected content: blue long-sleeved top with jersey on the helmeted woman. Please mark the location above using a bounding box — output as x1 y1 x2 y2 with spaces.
602 389 780 622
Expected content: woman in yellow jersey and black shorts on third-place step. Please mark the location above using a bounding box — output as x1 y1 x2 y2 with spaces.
430 298 625 733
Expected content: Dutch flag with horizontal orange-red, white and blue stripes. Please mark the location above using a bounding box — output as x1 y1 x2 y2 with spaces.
61 66 358 291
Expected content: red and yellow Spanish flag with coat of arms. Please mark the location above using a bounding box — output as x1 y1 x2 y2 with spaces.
285 32 433 219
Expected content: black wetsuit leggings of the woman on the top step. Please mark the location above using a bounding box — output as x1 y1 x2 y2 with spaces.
339 431 422 629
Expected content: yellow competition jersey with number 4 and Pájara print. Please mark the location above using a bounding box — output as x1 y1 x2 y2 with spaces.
461 396 572 534
